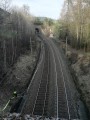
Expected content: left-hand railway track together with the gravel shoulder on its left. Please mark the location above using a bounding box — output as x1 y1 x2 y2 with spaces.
17 42 50 116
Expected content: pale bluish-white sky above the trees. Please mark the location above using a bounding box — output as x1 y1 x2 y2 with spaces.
12 0 64 19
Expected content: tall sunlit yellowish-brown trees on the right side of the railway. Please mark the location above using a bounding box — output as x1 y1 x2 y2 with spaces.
54 0 90 51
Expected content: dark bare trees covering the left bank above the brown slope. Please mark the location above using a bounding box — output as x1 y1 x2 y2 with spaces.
0 6 36 77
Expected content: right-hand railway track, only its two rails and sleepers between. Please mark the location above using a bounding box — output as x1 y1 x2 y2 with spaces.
51 42 70 120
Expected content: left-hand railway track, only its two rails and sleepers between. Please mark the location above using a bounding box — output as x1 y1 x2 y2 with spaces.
32 44 49 116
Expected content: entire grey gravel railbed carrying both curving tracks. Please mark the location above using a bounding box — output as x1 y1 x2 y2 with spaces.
15 36 78 120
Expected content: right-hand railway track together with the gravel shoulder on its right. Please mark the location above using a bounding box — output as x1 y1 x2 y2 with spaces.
47 39 78 120
